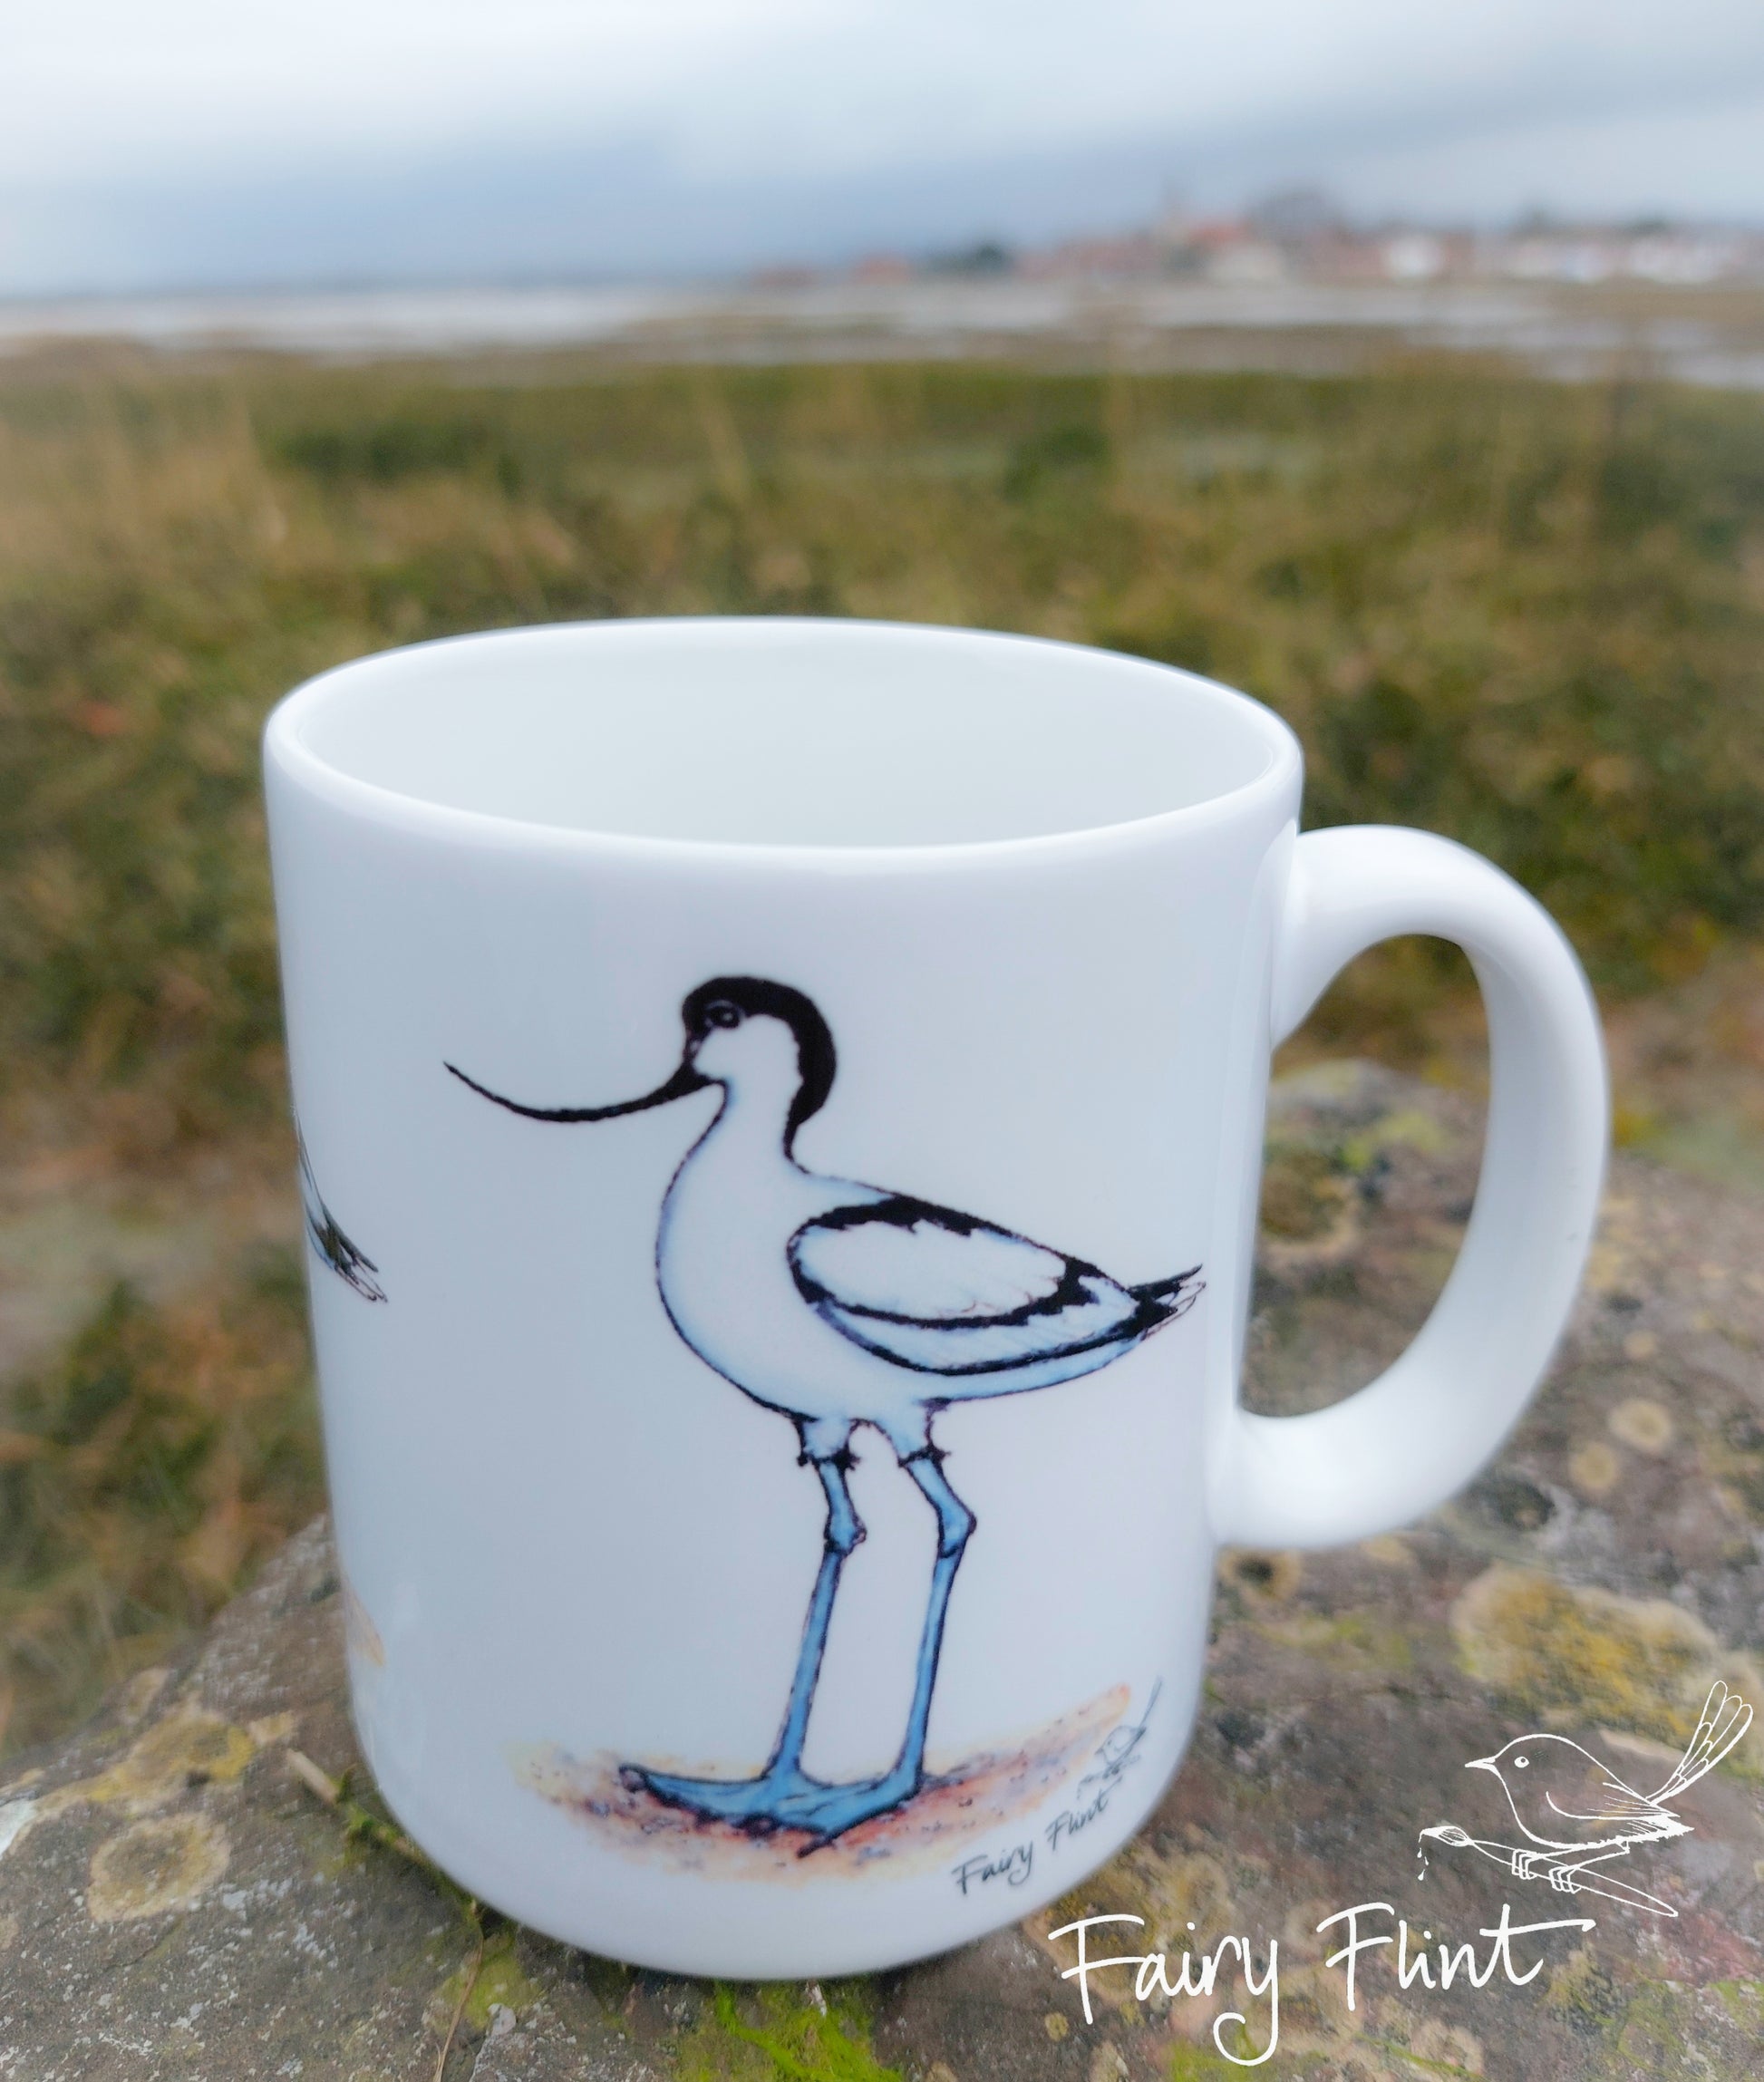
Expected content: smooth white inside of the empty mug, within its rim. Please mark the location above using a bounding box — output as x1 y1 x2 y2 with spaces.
268 618 1297 847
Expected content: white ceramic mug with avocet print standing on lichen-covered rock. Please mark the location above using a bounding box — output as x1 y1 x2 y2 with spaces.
267 621 1605 1976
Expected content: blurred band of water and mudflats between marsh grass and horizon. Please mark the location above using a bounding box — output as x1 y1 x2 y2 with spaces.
0 279 1764 390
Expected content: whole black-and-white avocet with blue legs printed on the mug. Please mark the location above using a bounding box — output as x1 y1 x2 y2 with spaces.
448 976 1199 1853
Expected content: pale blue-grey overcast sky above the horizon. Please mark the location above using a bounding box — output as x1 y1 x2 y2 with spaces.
0 0 1764 294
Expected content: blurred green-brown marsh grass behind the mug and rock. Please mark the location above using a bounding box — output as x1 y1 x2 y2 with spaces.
0 358 1764 1748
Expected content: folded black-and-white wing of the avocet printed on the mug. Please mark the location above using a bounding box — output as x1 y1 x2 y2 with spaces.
790 1193 1193 1376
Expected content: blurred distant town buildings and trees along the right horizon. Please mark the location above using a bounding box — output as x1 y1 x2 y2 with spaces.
754 189 1764 289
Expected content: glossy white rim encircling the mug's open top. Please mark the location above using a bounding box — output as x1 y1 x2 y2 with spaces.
262 615 1304 870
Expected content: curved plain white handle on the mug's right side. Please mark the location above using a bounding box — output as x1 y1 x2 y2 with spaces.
1214 825 1608 1547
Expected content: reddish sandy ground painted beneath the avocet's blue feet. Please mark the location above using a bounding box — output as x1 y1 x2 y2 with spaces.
510 1684 1131 1882
